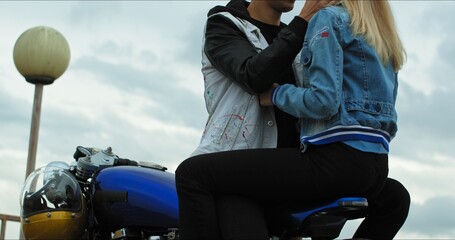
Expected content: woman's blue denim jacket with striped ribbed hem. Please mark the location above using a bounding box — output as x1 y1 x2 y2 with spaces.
272 5 398 153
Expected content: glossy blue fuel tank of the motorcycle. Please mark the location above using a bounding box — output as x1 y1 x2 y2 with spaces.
93 166 178 228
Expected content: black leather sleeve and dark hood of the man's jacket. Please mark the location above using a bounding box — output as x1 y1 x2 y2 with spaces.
204 0 308 94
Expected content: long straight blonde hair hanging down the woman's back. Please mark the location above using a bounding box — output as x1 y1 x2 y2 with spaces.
341 0 406 72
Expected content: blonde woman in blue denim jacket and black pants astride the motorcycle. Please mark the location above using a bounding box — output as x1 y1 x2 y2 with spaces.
176 0 410 239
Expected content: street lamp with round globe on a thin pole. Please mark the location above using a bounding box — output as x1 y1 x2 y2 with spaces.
13 26 70 178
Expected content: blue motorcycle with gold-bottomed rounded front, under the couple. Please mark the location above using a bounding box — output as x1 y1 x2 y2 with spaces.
20 146 368 240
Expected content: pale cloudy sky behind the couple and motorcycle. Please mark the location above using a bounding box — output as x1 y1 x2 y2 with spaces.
0 0 455 239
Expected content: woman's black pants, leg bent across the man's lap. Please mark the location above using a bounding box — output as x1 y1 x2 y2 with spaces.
176 143 410 240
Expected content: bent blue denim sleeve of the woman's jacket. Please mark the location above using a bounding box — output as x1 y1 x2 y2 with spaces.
272 10 343 120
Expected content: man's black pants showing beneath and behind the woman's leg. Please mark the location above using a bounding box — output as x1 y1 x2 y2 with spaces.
217 178 411 240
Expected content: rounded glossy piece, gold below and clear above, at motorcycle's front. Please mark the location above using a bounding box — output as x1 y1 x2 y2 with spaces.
20 162 87 239
